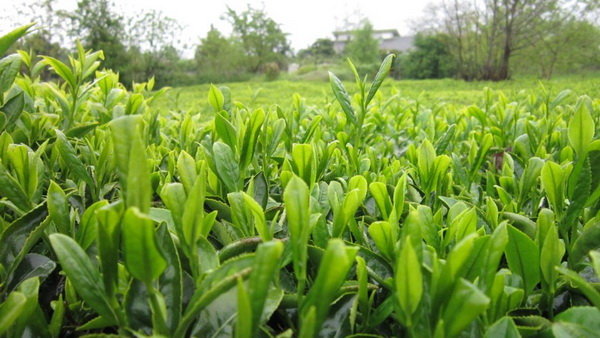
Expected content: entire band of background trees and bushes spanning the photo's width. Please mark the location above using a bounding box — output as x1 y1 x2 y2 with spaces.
2 0 600 87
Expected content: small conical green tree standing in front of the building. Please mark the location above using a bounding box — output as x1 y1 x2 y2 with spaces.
344 20 379 65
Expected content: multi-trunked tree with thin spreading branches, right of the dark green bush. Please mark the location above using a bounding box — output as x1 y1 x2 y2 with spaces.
427 0 597 81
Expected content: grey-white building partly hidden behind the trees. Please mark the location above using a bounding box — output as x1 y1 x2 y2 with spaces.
333 29 414 54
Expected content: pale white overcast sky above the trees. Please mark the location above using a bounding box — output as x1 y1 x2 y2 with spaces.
0 0 440 54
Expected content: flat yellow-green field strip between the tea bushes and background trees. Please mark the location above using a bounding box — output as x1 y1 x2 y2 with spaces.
156 73 600 116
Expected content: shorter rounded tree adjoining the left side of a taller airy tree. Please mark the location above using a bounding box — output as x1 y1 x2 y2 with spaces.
195 27 249 82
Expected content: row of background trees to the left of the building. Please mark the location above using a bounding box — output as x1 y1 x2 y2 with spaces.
5 0 291 87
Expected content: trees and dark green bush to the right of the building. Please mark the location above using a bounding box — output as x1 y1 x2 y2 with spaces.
400 0 600 81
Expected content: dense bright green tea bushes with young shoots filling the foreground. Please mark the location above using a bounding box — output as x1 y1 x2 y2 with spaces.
0 27 600 337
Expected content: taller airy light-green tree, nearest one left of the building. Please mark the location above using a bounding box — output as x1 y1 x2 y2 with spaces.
225 5 290 72
